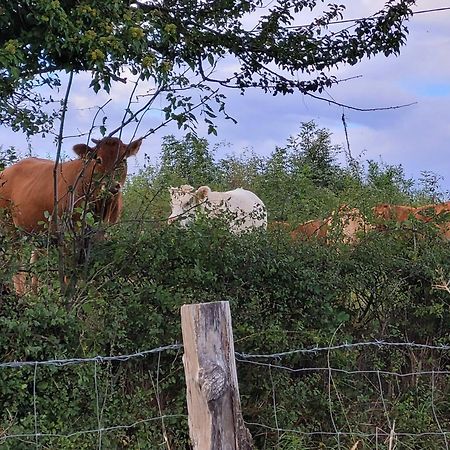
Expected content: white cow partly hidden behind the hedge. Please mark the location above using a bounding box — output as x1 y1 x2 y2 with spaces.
168 184 267 234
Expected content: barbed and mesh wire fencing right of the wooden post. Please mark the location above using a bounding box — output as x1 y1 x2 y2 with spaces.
241 340 450 450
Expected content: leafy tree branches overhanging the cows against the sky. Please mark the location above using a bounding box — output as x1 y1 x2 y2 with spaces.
0 0 415 133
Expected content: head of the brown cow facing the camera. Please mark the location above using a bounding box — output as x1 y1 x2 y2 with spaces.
73 137 142 195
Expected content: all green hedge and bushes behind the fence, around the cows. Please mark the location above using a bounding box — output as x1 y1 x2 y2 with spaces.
0 122 450 450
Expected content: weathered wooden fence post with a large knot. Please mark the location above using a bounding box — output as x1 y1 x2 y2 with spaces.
181 302 253 450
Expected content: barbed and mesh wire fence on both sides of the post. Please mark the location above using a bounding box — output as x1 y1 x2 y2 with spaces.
0 340 450 450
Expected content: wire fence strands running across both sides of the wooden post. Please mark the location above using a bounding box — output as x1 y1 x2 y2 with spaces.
0 340 450 450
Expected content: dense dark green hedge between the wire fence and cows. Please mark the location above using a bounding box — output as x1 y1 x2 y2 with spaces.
0 223 450 449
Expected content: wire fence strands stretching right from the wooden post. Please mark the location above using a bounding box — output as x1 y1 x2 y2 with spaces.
236 340 450 450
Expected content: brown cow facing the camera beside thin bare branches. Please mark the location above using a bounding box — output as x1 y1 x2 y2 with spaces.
0 137 142 293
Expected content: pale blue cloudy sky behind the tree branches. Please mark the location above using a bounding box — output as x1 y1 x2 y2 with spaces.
0 0 450 190
